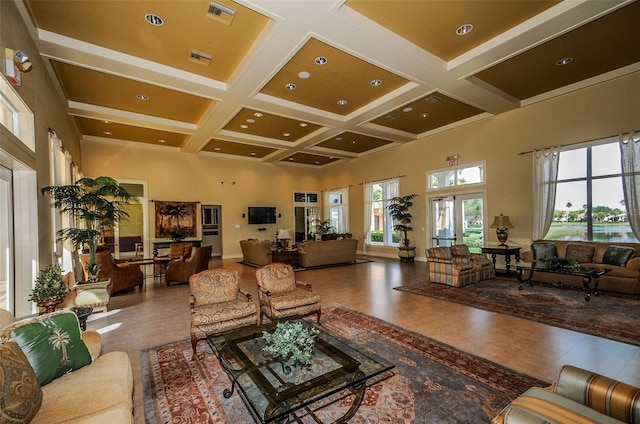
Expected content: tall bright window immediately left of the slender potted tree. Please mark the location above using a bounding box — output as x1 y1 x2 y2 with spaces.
364 179 400 246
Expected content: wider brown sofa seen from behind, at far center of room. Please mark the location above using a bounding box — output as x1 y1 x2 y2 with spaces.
298 239 358 268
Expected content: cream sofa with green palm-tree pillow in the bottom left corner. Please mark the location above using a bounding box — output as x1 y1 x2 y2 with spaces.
0 309 133 424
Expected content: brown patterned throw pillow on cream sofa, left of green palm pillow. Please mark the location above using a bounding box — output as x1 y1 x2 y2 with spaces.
0 342 42 423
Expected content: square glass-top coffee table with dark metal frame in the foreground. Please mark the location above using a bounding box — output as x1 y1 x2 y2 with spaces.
207 319 394 423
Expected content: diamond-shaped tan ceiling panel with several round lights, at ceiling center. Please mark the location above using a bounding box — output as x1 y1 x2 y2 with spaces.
260 38 409 115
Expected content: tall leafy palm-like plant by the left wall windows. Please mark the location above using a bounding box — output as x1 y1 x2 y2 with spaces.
42 177 139 282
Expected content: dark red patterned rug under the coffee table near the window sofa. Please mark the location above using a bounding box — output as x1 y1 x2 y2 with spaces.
395 278 640 346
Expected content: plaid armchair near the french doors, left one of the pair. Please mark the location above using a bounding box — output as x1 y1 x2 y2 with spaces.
426 247 473 287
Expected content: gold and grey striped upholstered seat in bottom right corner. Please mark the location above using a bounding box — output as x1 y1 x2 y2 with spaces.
491 365 640 424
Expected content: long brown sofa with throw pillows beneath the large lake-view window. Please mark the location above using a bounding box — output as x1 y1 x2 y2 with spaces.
520 240 640 294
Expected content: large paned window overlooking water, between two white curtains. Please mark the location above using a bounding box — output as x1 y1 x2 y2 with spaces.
545 140 638 242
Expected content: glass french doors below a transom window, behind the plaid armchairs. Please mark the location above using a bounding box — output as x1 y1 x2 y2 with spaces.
430 193 486 252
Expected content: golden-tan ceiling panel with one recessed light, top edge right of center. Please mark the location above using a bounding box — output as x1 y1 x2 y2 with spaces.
346 0 560 61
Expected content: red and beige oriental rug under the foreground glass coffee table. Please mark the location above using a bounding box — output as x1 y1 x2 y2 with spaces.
141 306 548 424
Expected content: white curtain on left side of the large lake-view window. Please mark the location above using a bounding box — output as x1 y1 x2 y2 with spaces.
532 147 560 240
